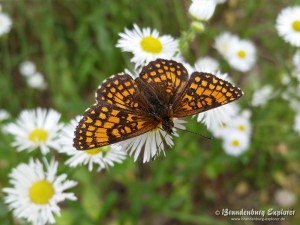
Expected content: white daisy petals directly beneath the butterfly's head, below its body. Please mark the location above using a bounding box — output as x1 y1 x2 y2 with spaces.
120 118 186 163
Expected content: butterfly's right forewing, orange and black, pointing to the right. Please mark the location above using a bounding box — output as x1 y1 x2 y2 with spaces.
173 72 243 117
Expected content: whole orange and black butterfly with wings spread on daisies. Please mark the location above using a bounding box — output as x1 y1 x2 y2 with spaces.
74 59 243 150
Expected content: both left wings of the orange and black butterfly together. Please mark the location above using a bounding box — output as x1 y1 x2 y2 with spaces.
73 74 158 150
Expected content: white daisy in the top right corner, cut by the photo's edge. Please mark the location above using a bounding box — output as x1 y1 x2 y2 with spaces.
276 6 300 47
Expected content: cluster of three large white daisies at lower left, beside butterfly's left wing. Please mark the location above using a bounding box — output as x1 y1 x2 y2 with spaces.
1 108 126 225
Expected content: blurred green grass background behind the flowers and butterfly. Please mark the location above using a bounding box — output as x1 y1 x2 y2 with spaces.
0 0 300 225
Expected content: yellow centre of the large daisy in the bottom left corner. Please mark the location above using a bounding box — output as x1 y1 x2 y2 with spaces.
29 180 54 204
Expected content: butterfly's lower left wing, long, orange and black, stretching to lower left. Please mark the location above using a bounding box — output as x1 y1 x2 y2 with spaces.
74 102 158 150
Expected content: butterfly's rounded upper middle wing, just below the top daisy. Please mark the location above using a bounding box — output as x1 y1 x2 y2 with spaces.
139 59 188 105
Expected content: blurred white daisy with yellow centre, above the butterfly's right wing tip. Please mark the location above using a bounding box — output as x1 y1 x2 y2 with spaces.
226 40 256 72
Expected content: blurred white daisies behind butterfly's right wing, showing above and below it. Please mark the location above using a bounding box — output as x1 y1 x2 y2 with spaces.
190 57 251 156
